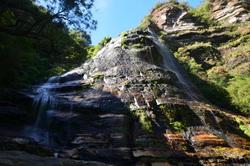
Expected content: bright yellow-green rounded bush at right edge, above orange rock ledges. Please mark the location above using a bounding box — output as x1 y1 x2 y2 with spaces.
226 76 250 115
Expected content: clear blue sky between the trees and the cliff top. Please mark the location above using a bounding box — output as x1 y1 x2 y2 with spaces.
90 0 200 45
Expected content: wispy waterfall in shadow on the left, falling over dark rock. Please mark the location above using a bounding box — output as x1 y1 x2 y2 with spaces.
31 76 60 147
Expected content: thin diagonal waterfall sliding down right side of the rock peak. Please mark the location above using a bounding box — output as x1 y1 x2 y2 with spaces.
148 28 203 101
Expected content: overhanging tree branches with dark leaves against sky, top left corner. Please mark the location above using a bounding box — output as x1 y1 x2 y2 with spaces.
0 0 97 38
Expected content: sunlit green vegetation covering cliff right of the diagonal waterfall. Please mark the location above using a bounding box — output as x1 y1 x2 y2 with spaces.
140 0 250 115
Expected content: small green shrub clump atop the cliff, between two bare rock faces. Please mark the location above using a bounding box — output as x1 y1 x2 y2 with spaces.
189 1 217 26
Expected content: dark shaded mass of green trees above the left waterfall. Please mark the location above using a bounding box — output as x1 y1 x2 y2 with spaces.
0 0 94 86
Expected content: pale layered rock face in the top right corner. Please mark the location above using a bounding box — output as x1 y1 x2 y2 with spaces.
209 0 250 24
